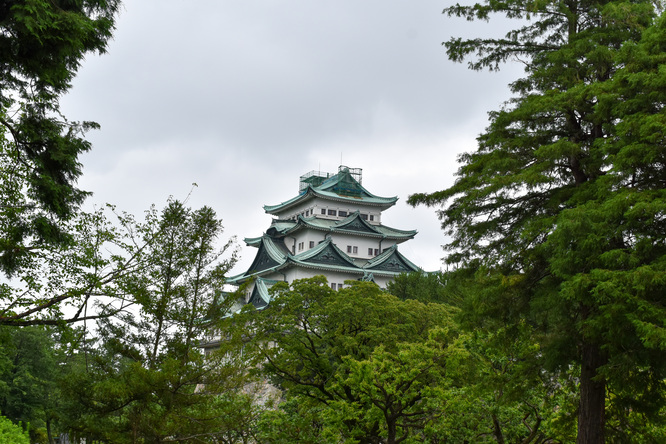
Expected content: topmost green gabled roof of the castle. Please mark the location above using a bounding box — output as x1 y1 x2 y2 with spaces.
264 167 398 214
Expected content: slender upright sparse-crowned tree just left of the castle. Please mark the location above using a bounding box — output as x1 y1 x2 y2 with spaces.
57 201 253 443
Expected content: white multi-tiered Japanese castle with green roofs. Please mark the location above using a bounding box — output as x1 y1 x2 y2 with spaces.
227 166 420 309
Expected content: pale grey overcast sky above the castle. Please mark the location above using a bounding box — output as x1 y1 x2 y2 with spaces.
62 0 521 274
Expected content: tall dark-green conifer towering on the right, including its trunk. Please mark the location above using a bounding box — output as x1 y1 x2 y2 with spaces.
409 0 666 444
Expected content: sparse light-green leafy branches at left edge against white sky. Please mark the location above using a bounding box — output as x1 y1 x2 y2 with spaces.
0 208 147 327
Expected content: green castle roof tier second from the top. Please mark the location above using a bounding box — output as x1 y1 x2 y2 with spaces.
264 211 417 246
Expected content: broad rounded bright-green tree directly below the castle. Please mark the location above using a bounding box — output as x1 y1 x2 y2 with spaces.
239 276 454 443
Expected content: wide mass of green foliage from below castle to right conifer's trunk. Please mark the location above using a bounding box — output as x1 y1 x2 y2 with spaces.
241 273 579 444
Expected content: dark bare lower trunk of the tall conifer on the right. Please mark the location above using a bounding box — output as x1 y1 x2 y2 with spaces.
576 343 606 444
